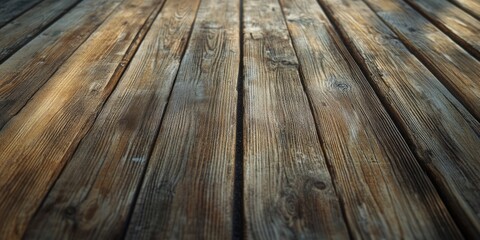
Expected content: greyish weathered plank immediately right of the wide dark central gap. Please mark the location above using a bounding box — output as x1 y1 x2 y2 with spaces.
243 0 348 239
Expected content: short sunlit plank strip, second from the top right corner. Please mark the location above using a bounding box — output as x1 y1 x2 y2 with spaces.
405 0 480 59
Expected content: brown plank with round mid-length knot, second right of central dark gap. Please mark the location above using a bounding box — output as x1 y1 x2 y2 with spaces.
280 0 462 239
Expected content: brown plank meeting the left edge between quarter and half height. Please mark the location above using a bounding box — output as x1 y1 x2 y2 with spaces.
0 0 121 128
